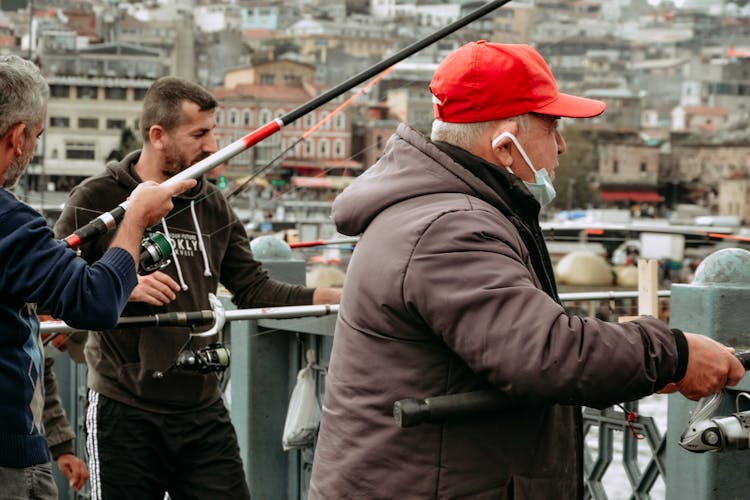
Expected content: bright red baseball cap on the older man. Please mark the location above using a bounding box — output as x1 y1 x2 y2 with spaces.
430 40 606 123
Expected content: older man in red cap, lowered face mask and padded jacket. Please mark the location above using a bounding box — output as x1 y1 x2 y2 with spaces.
309 41 744 500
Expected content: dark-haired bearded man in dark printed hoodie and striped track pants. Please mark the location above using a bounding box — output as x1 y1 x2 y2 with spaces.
55 77 341 500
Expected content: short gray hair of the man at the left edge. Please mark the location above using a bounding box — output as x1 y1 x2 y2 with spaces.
0 56 49 136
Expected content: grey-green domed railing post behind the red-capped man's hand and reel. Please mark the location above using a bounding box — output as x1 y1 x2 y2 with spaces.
666 248 750 500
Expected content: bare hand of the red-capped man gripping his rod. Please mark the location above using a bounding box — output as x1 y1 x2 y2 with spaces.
659 333 745 400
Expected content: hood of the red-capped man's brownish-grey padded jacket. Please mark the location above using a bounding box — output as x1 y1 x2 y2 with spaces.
332 123 510 236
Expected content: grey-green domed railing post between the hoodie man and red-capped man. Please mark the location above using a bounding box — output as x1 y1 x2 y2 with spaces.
230 236 305 499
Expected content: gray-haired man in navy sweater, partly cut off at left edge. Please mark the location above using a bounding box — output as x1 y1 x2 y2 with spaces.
0 56 195 500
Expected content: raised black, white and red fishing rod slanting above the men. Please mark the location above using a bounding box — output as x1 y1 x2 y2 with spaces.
63 0 510 248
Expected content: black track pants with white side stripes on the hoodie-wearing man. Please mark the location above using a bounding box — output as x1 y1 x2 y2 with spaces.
86 391 250 500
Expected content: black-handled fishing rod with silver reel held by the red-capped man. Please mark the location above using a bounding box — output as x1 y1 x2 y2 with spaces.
393 351 750 428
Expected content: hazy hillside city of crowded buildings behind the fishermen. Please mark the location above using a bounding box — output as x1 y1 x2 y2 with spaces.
0 0 750 237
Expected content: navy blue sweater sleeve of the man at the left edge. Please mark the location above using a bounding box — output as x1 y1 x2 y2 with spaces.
0 200 138 330
